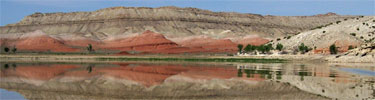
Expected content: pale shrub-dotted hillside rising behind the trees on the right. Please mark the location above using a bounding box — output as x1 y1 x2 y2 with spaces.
272 16 375 53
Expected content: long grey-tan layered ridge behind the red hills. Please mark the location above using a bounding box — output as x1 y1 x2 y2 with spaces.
0 7 353 39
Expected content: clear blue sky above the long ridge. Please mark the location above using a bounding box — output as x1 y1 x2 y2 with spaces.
0 0 375 26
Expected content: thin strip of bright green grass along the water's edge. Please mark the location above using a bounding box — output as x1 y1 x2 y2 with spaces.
96 57 286 63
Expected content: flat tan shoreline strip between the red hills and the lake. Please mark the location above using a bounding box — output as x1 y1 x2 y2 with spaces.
0 54 375 63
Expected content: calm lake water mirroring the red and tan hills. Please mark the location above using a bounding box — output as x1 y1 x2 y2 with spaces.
0 62 375 100
